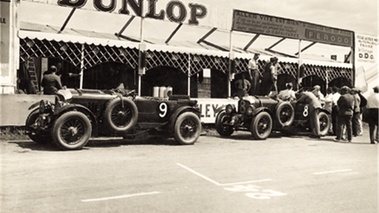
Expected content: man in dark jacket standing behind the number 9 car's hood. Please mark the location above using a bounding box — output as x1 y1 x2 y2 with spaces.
41 66 62 95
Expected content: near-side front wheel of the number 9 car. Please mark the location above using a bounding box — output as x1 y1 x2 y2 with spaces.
52 111 92 150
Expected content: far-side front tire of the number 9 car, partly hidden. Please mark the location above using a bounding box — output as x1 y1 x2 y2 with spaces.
25 109 51 144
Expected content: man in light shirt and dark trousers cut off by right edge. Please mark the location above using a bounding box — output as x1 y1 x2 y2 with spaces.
364 86 379 144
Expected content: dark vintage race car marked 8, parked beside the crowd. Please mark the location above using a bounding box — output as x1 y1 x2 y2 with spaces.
215 96 331 140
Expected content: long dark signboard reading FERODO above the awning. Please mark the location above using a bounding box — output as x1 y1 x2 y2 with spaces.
232 10 354 47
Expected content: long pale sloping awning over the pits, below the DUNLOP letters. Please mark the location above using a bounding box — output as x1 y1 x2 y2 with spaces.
18 1 352 68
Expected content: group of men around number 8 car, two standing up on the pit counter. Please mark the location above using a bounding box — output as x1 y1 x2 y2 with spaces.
239 54 379 144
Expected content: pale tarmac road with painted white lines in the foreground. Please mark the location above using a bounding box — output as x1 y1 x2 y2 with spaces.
0 132 378 213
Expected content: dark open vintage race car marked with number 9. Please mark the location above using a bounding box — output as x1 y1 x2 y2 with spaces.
25 89 201 150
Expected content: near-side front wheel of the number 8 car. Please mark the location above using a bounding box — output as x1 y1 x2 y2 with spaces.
250 112 272 140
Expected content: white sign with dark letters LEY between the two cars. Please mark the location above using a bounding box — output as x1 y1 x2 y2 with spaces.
194 98 238 124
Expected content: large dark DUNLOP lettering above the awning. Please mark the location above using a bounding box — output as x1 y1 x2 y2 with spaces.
58 0 207 25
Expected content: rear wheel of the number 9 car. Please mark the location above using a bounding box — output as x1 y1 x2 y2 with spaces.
174 112 201 145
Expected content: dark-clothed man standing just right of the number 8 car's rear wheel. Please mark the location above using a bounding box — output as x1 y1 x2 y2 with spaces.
335 86 354 142
